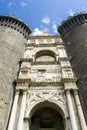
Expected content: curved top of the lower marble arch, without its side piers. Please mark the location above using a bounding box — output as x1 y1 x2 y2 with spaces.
25 99 68 119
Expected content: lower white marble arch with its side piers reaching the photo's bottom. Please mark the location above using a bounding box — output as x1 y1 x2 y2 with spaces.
24 99 71 130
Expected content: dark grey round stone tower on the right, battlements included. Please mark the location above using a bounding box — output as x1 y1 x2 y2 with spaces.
58 12 87 122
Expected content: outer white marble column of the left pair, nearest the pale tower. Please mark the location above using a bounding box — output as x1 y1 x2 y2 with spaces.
8 91 19 130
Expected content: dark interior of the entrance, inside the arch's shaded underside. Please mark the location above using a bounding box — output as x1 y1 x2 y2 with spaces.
30 107 64 130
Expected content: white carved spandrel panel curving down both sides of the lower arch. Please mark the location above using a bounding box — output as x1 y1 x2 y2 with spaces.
25 90 67 117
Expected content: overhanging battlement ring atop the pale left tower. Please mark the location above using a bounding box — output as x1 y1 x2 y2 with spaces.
0 15 31 38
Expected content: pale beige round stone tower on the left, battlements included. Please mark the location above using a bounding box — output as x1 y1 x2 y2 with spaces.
0 15 31 130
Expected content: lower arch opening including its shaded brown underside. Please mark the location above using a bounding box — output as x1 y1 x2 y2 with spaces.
29 101 66 130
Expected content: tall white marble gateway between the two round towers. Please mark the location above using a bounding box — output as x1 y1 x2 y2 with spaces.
7 32 86 130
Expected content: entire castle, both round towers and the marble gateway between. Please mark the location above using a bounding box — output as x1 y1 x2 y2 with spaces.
0 13 87 130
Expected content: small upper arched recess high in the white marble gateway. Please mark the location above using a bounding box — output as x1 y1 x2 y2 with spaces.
35 50 56 61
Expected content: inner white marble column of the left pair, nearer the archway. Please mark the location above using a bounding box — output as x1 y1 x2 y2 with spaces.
17 91 26 130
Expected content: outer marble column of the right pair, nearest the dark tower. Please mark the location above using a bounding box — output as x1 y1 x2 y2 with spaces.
73 90 87 130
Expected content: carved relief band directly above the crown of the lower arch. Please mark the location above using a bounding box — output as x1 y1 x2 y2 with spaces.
27 90 66 107
